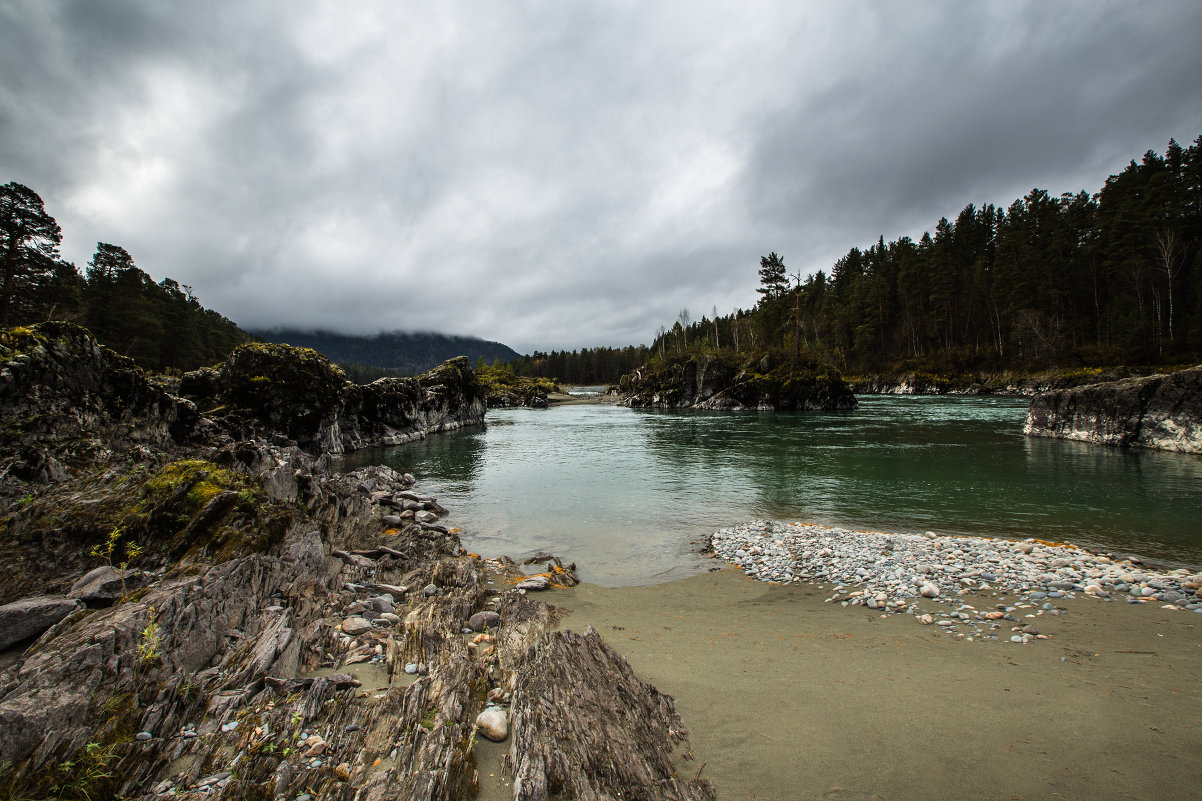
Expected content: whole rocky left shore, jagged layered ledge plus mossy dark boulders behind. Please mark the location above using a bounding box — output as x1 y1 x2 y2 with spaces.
0 326 713 801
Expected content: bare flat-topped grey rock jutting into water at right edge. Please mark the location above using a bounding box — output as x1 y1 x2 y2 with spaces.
1023 367 1202 453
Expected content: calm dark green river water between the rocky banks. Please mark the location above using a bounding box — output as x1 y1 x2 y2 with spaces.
338 397 1202 586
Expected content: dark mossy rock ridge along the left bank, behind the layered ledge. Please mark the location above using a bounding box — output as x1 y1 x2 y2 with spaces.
0 322 484 459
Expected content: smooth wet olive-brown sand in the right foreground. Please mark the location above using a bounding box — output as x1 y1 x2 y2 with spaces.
552 569 1202 801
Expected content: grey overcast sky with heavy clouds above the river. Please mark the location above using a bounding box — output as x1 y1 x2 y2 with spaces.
0 0 1202 352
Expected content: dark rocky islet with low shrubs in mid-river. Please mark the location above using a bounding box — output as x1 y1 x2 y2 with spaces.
619 354 856 411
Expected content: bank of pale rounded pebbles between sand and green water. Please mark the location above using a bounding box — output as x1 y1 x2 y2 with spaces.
710 521 1202 643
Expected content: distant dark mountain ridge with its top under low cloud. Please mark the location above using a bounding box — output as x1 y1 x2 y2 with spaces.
250 328 520 374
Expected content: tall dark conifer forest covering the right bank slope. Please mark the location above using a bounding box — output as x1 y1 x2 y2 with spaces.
514 136 1202 384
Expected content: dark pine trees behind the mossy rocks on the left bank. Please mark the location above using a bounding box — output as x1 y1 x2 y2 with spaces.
0 183 249 372
